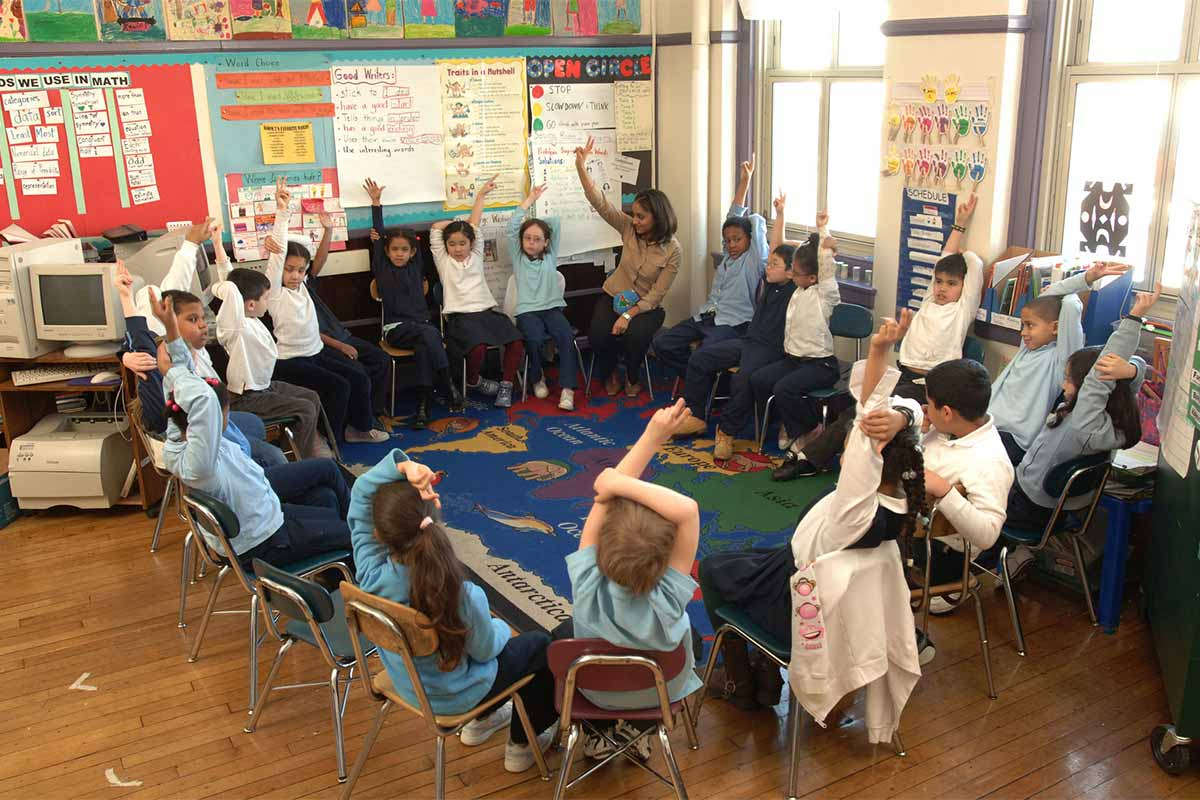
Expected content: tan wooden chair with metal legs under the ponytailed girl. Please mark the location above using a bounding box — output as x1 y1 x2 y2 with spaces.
341 582 550 800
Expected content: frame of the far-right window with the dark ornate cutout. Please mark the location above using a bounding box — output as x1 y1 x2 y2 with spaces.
1037 0 1200 295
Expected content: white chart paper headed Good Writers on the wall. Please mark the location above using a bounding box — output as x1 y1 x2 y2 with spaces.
329 64 445 207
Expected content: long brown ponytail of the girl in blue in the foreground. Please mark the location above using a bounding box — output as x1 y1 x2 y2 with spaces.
372 481 467 672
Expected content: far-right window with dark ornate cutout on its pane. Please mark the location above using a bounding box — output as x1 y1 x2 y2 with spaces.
1039 0 1200 289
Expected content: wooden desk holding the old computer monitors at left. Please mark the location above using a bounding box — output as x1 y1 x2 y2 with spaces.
0 350 167 510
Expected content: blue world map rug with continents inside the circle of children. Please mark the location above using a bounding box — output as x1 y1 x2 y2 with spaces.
342 391 833 636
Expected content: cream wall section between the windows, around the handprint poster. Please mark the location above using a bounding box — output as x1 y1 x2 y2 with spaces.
874 0 1025 372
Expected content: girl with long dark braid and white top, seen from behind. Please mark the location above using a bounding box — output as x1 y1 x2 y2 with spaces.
700 311 929 709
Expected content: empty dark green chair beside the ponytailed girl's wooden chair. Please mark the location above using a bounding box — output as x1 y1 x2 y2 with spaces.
244 559 376 781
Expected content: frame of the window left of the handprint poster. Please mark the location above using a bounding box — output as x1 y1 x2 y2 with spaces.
754 12 883 258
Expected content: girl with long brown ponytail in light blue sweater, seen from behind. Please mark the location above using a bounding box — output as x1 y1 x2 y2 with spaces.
348 450 557 772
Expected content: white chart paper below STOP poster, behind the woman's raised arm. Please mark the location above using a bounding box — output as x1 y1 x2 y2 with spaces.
529 131 620 255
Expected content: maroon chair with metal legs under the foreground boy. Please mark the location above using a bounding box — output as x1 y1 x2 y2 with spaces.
547 638 700 800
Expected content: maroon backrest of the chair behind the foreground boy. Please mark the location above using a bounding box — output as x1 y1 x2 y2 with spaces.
546 638 691 692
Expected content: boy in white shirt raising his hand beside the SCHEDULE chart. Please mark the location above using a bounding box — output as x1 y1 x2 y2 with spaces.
792 194 983 477
